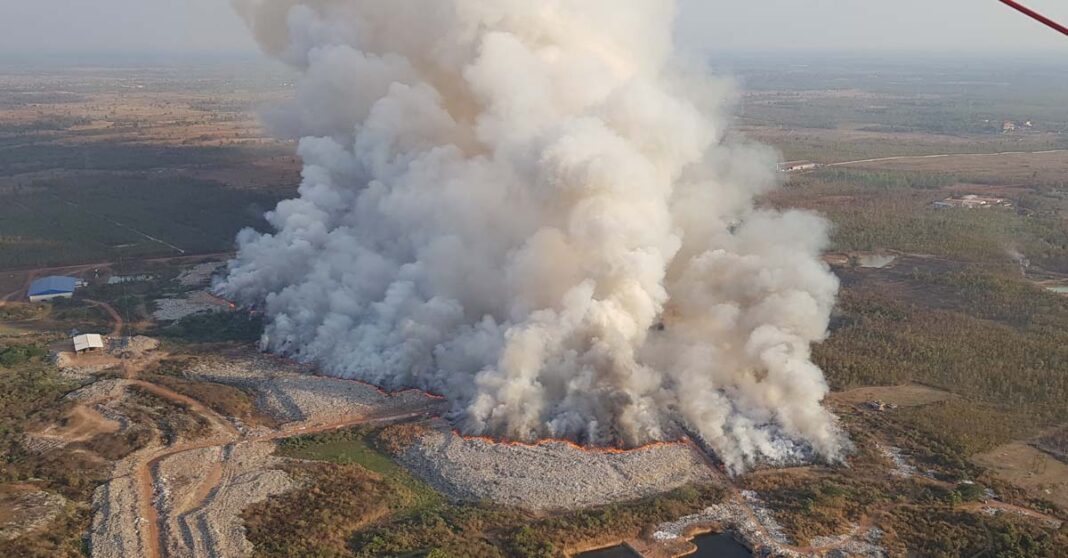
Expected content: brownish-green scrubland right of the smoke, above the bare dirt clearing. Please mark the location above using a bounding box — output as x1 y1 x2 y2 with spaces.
815 275 1068 427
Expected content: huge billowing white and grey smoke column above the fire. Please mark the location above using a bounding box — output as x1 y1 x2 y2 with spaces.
218 0 846 470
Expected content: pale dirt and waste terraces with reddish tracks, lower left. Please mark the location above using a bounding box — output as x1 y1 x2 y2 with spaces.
82 344 439 558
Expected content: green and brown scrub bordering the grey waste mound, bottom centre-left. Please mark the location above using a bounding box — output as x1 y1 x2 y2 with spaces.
245 425 723 558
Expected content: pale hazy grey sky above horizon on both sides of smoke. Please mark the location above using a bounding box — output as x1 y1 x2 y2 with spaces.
0 0 1068 56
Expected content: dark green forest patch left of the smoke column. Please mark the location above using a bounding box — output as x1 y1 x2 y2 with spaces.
0 175 283 268
